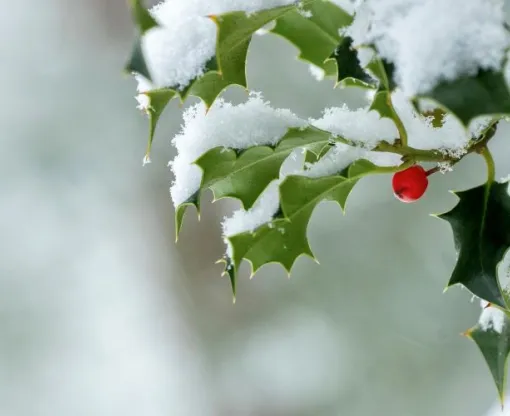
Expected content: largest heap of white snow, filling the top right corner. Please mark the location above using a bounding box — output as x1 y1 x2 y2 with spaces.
347 0 510 96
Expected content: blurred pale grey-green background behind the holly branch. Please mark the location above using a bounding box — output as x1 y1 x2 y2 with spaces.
0 0 510 416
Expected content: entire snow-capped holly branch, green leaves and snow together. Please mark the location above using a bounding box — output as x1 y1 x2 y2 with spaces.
126 0 510 404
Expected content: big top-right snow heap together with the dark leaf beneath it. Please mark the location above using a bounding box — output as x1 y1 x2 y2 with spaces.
346 0 510 125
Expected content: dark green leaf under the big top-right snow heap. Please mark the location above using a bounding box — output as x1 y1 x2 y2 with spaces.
424 70 510 126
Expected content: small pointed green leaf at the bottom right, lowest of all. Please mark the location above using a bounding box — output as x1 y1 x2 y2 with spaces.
465 312 510 404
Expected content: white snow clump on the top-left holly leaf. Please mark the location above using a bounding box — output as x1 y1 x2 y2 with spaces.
137 0 295 89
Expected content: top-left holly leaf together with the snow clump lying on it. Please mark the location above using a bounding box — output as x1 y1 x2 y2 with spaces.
127 0 310 158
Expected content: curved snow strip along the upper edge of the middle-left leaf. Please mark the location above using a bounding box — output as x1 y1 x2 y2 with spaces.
170 93 307 206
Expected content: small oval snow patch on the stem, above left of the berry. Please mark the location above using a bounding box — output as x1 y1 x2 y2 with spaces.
310 104 398 149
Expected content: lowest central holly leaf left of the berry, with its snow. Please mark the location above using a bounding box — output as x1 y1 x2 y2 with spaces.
224 156 377 290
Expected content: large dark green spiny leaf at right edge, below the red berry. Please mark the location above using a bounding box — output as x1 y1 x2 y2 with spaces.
439 181 510 309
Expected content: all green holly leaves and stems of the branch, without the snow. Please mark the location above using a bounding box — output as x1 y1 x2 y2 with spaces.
127 0 510 404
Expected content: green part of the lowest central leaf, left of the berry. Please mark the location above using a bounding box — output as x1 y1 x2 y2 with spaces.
227 160 377 279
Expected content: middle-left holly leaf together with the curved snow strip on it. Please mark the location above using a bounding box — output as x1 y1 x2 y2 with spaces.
170 94 306 236
